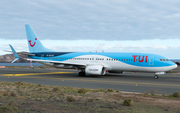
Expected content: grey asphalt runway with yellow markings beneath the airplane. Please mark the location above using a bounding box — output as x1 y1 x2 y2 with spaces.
0 68 180 94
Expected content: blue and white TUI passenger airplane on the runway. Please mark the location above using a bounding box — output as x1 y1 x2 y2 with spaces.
10 24 177 79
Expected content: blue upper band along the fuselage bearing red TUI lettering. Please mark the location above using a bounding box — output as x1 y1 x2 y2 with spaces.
29 52 175 67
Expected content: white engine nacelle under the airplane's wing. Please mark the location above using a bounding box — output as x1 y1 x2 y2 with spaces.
85 65 106 75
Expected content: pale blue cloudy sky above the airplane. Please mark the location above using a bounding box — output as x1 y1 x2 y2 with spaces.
0 0 180 59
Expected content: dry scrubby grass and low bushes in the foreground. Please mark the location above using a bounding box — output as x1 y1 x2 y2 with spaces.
0 82 180 113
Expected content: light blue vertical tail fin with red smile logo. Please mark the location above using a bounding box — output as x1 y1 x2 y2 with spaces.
25 24 52 53
